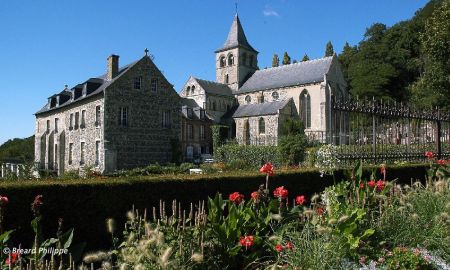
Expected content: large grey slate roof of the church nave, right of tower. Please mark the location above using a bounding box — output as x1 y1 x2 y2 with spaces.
236 56 333 94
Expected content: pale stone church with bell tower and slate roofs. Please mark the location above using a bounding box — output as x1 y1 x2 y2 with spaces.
180 14 348 150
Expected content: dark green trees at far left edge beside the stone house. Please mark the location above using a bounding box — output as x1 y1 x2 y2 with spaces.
0 136 34 163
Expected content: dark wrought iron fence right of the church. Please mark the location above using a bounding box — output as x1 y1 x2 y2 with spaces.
326 99 450 163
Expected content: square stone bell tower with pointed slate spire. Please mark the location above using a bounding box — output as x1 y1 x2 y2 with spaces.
215 14 258 91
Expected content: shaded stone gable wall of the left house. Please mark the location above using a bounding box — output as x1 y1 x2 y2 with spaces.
105 56 181 170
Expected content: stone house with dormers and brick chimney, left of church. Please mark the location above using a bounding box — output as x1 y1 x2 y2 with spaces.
35 51 181 174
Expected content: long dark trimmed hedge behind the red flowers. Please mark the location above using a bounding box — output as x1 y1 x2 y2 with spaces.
0 165 427 250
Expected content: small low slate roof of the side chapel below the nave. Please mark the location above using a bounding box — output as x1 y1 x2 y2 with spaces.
233 98 292 118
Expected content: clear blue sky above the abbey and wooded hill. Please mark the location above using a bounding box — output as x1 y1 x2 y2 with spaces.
0 0 427 144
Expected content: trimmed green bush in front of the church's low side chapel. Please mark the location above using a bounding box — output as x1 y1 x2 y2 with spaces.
214 144 282 170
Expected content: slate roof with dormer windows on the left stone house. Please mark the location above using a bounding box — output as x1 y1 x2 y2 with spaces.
35 60 139 115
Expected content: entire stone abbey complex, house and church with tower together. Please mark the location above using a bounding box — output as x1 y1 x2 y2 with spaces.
35 15 348 173
